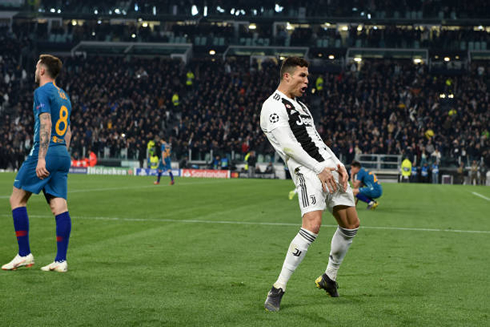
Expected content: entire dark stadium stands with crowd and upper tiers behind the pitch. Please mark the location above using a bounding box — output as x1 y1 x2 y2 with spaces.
0 0 490 183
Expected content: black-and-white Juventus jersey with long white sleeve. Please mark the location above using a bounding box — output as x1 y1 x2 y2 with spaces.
260 90 341 174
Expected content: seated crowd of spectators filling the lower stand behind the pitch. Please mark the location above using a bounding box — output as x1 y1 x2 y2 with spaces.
0 26 490 173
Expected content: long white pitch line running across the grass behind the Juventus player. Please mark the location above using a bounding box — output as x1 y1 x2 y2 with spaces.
0 214 490 234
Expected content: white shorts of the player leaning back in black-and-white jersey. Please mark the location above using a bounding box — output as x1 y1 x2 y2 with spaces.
291 167 356 217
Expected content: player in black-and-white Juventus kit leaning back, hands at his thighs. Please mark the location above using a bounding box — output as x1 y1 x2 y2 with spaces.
260 57 359 311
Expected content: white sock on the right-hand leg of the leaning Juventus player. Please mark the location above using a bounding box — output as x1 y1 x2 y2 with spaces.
325 226 359 280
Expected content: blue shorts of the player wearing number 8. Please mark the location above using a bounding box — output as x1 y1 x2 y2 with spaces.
14 145 71 200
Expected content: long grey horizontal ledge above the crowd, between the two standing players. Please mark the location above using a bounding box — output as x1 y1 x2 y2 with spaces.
71 41 192 62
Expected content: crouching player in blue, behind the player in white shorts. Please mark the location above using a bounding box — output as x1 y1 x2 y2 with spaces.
350 161 383 210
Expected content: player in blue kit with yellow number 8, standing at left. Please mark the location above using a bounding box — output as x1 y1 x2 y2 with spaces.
2 55 71 272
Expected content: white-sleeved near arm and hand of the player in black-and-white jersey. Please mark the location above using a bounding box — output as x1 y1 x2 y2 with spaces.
271 126 337 193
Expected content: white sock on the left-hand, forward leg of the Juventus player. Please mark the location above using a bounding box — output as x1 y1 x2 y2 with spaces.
274 228 318 291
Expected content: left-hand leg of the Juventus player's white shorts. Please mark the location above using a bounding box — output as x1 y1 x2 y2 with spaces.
292 168 326 217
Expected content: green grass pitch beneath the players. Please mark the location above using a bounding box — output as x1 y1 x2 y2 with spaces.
0 173 490 326
